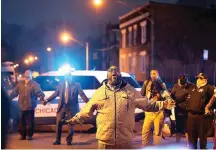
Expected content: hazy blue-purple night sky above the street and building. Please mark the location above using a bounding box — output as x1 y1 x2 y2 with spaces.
1 0 216 72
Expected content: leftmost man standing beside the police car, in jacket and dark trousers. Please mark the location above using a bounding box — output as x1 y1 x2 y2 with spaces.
10 70 45 140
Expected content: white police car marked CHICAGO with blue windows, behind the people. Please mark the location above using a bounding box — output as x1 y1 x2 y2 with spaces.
13 67 143 125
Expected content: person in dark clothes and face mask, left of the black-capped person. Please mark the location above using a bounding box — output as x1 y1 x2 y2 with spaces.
171 74 195 145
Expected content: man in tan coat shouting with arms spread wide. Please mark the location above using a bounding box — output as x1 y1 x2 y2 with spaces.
70 66 174 149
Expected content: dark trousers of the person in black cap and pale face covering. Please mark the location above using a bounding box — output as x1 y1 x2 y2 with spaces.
187 112 207 149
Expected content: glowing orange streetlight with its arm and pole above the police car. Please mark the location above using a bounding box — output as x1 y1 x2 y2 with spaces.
60 32 89 70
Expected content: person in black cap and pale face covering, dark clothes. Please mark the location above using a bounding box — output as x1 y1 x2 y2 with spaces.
186 73 214 149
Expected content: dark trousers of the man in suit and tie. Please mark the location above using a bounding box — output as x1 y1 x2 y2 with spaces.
56 108 74 142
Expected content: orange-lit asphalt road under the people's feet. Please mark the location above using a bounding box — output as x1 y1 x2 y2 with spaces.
7 122 213 149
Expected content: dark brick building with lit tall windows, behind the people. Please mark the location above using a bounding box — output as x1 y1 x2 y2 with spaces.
119 2 216 83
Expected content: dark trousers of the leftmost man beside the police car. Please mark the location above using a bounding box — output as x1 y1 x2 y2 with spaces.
19 110 35 137
